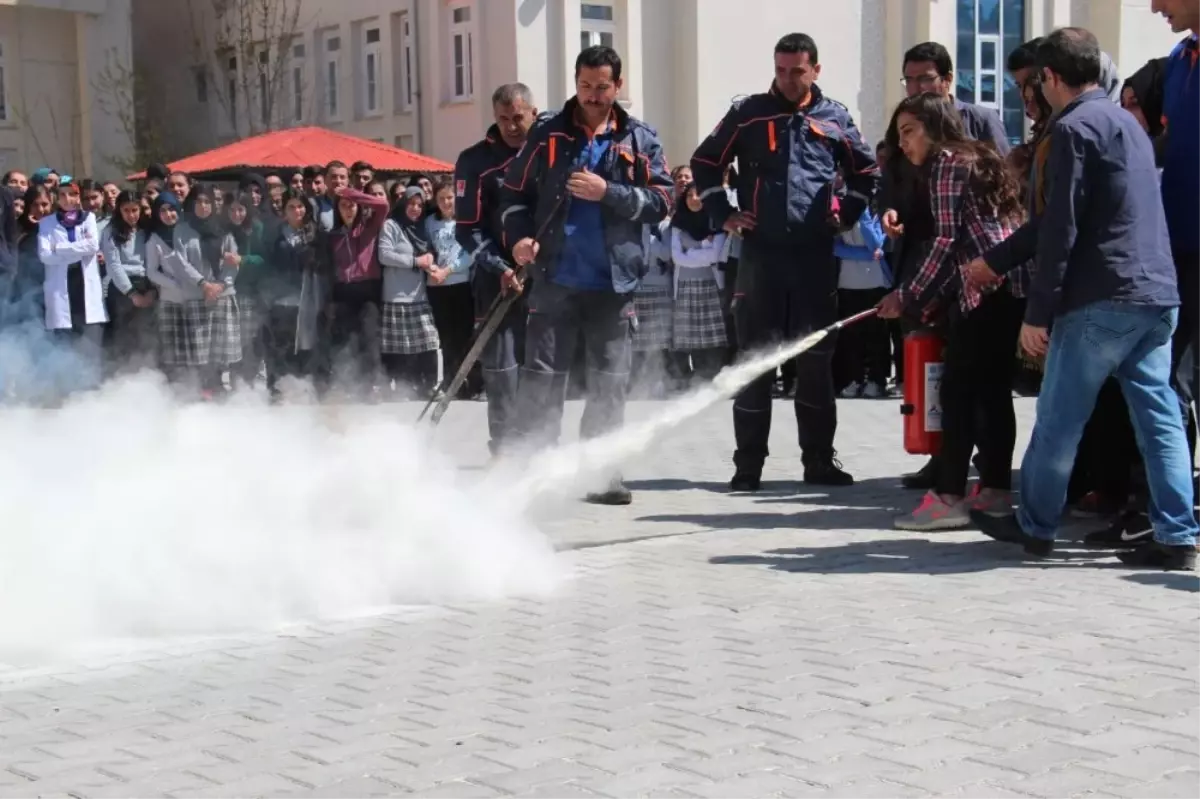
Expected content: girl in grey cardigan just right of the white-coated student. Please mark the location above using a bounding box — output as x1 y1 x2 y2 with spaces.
100 191 157 374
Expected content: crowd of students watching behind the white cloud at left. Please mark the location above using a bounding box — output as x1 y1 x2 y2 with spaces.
0 161 481 403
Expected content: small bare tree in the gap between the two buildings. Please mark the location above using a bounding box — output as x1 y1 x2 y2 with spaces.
91 50 167 174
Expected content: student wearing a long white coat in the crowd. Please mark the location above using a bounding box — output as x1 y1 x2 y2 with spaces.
37 182 108 391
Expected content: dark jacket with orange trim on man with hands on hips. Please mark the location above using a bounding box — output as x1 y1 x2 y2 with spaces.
691 84 880 252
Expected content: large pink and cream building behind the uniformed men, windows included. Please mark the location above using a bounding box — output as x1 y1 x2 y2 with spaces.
129 0 1175 163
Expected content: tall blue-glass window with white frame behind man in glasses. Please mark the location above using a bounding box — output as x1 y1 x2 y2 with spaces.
954 0 1026 144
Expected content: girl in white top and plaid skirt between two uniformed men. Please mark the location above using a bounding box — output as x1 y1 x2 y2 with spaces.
671 184 728 380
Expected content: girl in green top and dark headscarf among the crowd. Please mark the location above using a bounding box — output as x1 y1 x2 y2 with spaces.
226 194 266 386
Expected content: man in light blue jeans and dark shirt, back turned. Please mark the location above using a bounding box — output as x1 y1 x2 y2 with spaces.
971 28 1196 570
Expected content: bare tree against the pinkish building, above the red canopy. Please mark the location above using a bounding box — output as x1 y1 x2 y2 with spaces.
187 0 307 133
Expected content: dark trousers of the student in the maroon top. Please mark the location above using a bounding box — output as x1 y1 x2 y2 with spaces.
325 281 383 391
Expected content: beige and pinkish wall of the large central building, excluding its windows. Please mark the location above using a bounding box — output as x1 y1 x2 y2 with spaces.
131 0 1174 163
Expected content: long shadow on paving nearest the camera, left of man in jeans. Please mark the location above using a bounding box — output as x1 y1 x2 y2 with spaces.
709 539 1091 575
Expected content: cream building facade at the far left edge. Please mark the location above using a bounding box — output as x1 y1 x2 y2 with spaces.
0 0 134 178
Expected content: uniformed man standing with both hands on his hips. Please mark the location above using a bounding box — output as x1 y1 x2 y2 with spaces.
691 34 878 491
